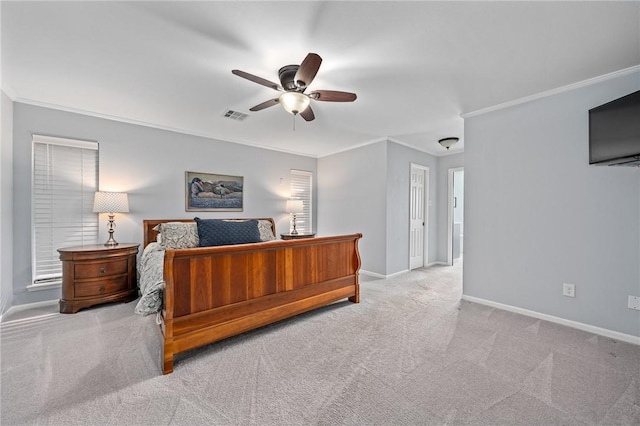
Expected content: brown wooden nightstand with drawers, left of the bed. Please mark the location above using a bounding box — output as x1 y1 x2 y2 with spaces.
58 243 139 314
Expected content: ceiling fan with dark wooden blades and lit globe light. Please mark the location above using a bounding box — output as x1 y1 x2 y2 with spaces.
231 53 356 121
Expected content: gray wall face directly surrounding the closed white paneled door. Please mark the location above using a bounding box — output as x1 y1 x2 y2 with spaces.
386 141 446 275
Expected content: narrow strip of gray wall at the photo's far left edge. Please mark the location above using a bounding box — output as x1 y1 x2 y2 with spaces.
0 92 13 315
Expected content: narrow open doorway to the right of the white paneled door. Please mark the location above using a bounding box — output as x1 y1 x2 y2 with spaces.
447 167 464 265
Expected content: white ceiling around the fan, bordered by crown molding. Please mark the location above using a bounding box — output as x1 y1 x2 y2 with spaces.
1 1 640 157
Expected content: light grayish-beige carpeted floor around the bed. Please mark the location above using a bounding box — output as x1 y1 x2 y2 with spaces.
0 265 640 425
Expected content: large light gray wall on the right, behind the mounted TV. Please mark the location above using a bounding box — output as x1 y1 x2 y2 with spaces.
463 72 640 336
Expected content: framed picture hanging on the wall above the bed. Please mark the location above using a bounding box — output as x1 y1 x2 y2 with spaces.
185 172 244 212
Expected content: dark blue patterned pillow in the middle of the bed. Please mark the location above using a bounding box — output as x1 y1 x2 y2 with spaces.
194 217 261 247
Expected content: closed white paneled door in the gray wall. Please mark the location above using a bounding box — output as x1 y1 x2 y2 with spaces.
409 164 429 269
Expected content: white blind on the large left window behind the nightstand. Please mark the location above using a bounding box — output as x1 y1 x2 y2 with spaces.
30 135 98 287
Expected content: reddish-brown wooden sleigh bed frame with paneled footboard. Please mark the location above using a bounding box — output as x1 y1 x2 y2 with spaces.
143 219 362 374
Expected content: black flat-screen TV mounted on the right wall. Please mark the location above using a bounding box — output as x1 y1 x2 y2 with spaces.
589 90 640 166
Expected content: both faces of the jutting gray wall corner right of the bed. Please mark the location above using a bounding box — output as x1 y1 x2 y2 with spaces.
318 141 446 275
